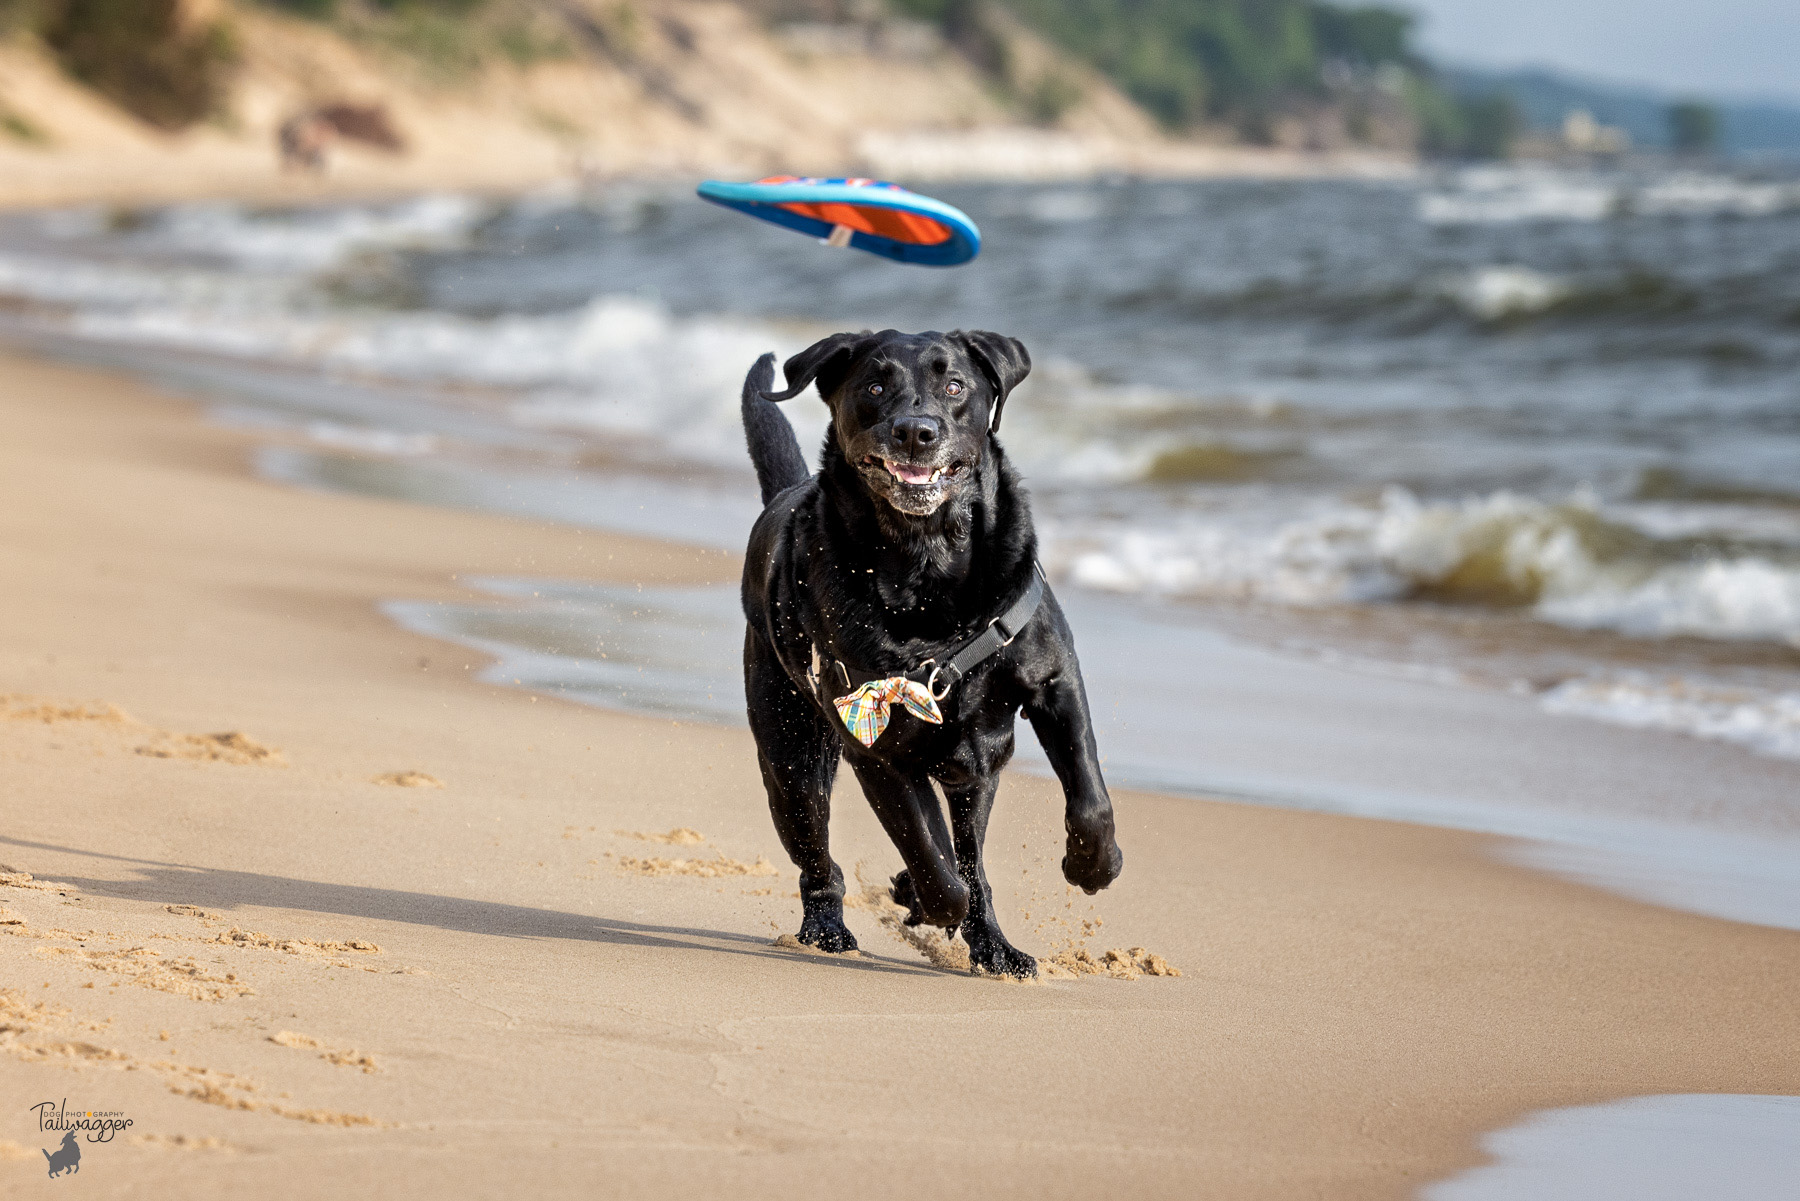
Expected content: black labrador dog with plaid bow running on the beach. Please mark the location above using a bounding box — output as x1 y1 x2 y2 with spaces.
743 330 1125 976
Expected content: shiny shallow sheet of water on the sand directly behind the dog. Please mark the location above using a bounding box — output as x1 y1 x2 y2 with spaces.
383 568 1800 929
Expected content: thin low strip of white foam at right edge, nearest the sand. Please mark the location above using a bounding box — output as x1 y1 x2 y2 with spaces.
1541 673 1800 758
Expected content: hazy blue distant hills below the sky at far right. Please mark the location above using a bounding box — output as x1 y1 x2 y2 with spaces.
1440 67 1800 155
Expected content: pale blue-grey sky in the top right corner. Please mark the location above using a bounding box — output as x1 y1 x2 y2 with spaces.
1395 0 1800 101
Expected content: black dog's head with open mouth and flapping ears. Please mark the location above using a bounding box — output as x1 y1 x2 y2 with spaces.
769 330 1031 517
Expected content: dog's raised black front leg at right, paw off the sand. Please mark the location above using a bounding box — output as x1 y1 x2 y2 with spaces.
1024 666 1125 893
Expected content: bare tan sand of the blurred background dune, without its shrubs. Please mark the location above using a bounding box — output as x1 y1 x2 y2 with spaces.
0 0 1404 207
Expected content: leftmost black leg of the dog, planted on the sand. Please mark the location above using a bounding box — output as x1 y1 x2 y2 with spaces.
743 630 857 953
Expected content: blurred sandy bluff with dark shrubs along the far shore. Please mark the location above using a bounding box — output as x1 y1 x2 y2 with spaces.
0 0 1411 205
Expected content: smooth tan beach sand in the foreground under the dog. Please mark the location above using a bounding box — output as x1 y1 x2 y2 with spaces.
0 342 1800 1197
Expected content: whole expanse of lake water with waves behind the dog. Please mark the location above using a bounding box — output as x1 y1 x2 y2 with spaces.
0 167 1800 926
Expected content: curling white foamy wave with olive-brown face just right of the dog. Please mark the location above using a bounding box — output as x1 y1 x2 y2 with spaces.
1048 488 1800 645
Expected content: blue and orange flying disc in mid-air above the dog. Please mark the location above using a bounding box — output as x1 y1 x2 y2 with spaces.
698 175 981 266
